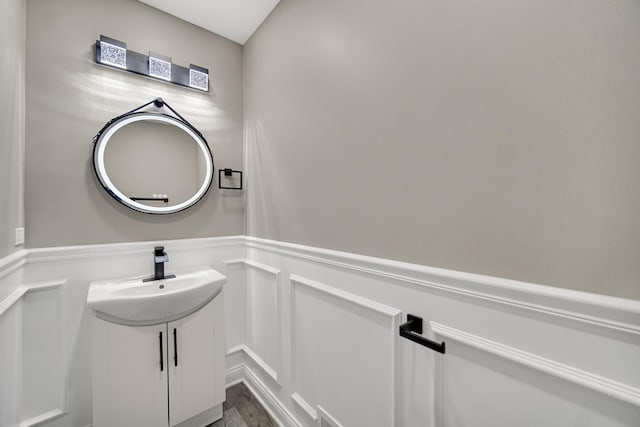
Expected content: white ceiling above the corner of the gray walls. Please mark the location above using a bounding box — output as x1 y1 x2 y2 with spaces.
140 0 280 44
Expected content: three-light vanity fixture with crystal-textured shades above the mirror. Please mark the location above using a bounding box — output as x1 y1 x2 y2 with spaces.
96 35 209 92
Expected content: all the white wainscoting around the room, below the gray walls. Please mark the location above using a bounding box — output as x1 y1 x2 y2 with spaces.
0 236 640 427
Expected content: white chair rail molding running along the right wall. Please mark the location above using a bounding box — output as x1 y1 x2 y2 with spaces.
245 237 640 335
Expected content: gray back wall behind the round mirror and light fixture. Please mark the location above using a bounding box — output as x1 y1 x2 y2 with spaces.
25 0 245 248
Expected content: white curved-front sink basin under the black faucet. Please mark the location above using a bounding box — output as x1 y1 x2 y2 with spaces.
87 267 227 326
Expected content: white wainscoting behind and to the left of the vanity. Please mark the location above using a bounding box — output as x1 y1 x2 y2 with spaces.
0 236 245 427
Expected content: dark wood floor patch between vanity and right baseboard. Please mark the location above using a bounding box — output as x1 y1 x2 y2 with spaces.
208 383 277 427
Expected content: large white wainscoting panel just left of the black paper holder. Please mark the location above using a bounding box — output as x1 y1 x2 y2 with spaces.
291 275 400 427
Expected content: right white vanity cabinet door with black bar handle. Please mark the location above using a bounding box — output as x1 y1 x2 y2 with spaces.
168 293 225 426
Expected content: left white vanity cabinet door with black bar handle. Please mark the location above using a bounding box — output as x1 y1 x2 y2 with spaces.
93 318 169 427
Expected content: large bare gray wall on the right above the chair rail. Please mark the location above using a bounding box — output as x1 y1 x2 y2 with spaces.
243 0 640 298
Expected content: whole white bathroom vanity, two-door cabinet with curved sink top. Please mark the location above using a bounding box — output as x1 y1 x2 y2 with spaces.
87 268 226 427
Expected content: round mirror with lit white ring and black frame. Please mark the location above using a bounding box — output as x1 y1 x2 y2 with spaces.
93 112 213 214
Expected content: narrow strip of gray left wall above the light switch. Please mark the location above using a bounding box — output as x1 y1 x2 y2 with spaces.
0 0 26 258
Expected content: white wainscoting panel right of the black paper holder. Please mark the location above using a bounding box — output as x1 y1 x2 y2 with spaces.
441 340 640 427
